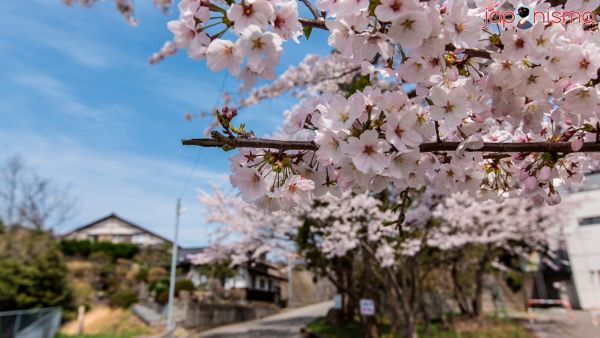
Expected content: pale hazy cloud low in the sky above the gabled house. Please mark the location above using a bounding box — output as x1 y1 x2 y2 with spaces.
0 131 224 245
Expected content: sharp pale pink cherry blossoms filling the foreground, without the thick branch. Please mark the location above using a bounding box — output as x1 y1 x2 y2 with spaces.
81 0 600 209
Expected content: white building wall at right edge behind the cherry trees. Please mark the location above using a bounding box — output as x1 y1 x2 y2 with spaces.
565 190 600 309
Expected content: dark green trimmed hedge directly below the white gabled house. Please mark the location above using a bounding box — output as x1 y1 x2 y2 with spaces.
60 239 139 260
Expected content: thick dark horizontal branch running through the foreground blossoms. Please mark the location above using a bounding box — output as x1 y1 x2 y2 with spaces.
182 133 600 157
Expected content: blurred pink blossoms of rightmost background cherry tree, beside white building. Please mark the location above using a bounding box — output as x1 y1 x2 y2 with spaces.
427 193 569 251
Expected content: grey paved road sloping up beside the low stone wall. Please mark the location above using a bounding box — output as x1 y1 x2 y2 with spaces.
199 302 333 338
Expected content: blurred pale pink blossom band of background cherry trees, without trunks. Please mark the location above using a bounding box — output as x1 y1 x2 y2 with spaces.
192 187 569 267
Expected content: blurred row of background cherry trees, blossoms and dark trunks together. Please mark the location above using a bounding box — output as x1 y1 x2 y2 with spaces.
193 187 566 337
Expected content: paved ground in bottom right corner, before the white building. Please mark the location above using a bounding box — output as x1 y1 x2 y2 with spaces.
526 310 600 338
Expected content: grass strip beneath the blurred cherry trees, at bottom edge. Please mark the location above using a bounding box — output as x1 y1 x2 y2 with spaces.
308 318 533 338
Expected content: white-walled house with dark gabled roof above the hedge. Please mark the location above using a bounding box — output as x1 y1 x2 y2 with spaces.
62 213 172 246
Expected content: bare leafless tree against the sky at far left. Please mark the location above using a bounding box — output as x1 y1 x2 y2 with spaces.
0 156 75 230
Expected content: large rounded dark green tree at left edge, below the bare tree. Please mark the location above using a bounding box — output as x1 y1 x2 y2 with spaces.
0 226 73 311
